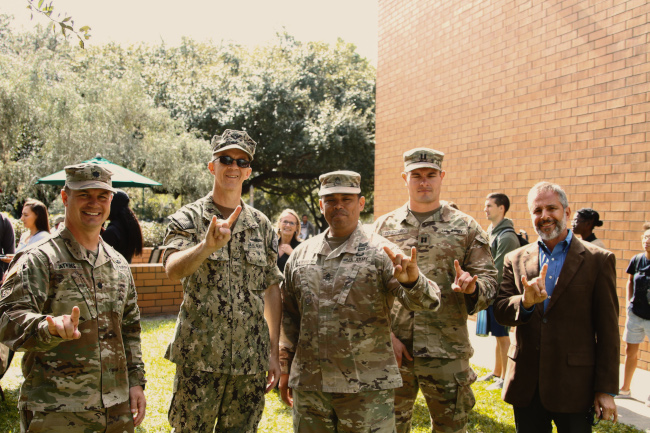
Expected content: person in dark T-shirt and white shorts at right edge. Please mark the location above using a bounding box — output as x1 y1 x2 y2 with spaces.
618 223 650 407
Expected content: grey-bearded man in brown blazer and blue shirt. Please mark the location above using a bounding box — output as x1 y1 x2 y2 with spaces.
494 182 620 433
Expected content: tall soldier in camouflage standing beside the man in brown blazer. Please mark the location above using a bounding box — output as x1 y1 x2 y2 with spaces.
374 148 497 433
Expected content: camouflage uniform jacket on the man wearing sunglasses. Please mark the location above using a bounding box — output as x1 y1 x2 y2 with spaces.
163 194 282 375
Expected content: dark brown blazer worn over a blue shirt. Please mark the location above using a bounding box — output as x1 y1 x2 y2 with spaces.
494 237 620 413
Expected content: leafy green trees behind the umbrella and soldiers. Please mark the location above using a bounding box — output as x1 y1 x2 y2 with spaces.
0 15 375 226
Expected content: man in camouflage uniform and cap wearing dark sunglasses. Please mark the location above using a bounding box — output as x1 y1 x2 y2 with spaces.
163 130 282 433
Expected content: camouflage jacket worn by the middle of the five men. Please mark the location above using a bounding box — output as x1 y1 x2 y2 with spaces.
280 224 440 393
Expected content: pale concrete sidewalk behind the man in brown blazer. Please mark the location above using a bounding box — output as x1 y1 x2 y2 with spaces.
467 320 650 433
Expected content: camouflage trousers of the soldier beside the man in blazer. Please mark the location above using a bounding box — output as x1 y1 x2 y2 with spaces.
395 357 476 433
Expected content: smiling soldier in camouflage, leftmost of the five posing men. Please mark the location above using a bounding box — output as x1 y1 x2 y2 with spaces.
0 164 146 433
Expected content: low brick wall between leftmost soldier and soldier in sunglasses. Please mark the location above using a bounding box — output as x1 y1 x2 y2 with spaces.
131 263 183 316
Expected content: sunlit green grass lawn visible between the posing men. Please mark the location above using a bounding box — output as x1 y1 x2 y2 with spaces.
0 318 643 433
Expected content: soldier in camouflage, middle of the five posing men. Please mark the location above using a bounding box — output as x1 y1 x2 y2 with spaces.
280 171 439 433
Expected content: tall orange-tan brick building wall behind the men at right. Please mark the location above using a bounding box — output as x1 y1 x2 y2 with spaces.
375 0 650 369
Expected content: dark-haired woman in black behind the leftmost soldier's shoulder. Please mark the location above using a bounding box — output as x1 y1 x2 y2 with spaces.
102 189 144 263
